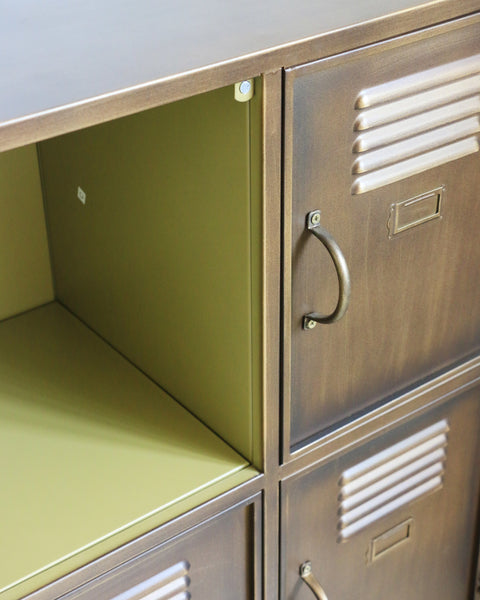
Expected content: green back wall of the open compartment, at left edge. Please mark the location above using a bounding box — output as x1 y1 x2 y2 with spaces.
0 146 53 319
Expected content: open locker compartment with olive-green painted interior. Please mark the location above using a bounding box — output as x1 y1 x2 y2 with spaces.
0 87 261 600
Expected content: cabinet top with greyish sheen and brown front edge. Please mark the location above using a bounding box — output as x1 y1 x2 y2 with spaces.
0 0 480 149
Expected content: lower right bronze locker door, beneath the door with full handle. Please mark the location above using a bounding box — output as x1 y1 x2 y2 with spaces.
282 387 480 600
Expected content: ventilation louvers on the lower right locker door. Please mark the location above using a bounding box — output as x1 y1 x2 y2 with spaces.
338 420 448 541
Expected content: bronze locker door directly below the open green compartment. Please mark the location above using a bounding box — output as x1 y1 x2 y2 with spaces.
55 499 261 600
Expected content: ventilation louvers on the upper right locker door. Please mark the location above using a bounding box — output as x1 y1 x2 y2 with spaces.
352 54 480 194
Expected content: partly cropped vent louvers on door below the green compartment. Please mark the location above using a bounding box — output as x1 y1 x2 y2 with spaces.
111 561 191 600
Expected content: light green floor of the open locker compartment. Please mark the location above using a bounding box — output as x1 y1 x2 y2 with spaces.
0 303 252 600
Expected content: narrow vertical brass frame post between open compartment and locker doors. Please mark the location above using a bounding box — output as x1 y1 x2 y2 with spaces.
255 70 283 598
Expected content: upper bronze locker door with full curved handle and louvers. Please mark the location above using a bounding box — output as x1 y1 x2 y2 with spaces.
285 16 480 450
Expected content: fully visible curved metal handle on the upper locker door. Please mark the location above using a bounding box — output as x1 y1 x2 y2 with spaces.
303 210 351 330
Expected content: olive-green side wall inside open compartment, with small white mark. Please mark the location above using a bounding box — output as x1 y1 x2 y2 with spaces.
40 86 260 460
